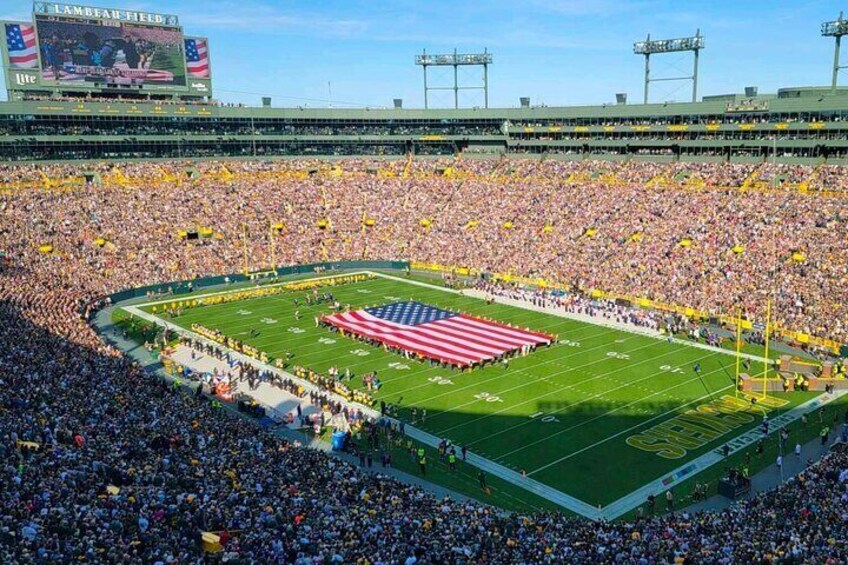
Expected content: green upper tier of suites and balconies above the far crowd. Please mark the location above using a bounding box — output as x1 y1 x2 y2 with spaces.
0 88 848 164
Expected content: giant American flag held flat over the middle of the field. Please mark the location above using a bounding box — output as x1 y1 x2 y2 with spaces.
323 301 553 367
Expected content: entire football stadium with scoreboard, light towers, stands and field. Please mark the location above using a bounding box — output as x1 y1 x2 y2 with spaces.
0 2 848 565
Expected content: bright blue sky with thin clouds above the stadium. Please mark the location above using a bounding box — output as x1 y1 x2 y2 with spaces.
0 0 848 107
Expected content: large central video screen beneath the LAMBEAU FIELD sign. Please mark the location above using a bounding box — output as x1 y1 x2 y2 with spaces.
34 16 186 87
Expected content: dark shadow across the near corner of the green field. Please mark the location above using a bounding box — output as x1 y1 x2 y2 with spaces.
384 373 800 505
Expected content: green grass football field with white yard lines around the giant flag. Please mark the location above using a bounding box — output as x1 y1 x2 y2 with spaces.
129 270 814 506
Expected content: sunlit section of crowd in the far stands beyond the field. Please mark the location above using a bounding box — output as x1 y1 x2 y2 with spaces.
0 159 848 342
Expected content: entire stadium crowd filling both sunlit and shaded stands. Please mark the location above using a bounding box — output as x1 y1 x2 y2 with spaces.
0 159 848 565
